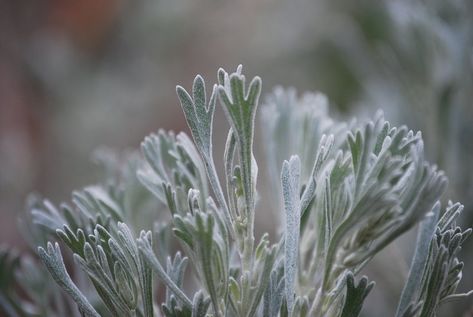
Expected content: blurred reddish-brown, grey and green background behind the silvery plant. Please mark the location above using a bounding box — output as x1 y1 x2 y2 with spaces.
0 0 473 316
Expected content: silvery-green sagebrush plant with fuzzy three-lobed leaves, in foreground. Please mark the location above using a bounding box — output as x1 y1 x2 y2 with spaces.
0 66 471 317
